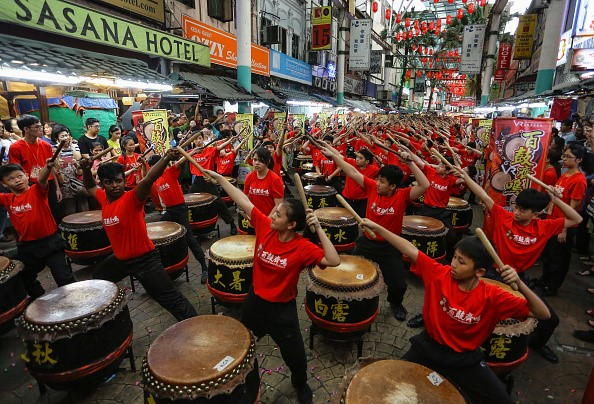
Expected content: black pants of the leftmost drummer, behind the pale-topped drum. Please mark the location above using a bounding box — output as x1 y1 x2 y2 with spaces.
16 233 76 298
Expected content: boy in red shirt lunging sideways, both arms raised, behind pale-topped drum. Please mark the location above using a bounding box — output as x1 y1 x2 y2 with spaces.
80 149 198 321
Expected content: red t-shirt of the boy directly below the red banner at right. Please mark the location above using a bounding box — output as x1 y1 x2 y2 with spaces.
491 204 565 272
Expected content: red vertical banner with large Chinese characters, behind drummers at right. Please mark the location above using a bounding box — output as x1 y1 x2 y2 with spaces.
484 118 553 234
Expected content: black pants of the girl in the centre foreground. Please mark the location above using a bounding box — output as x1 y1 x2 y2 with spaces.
241 288 307 386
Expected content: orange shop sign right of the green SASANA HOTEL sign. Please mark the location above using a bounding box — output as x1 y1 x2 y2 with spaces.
182 15 270 76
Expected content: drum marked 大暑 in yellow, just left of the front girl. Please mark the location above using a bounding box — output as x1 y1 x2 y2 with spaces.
207 235 256 303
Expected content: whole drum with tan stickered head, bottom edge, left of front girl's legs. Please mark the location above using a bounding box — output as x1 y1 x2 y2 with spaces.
142 316 260 404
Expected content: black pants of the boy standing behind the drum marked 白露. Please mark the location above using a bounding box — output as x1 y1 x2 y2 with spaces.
353 235 408 306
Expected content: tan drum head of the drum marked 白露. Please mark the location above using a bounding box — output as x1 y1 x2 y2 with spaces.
311 255 378 288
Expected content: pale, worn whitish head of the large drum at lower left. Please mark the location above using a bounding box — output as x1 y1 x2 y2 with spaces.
25 279 118 325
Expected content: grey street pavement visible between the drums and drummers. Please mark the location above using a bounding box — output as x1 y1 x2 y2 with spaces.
0 206 594 404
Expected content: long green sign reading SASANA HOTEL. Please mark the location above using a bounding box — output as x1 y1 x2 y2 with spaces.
0 0 210 67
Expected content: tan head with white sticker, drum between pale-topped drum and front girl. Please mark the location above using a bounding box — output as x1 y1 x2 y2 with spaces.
146 316 251 386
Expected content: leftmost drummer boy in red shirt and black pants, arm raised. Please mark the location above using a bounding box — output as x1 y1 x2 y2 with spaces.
0 160 76 299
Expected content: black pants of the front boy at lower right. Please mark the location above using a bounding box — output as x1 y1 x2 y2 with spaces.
402 331 513 404
